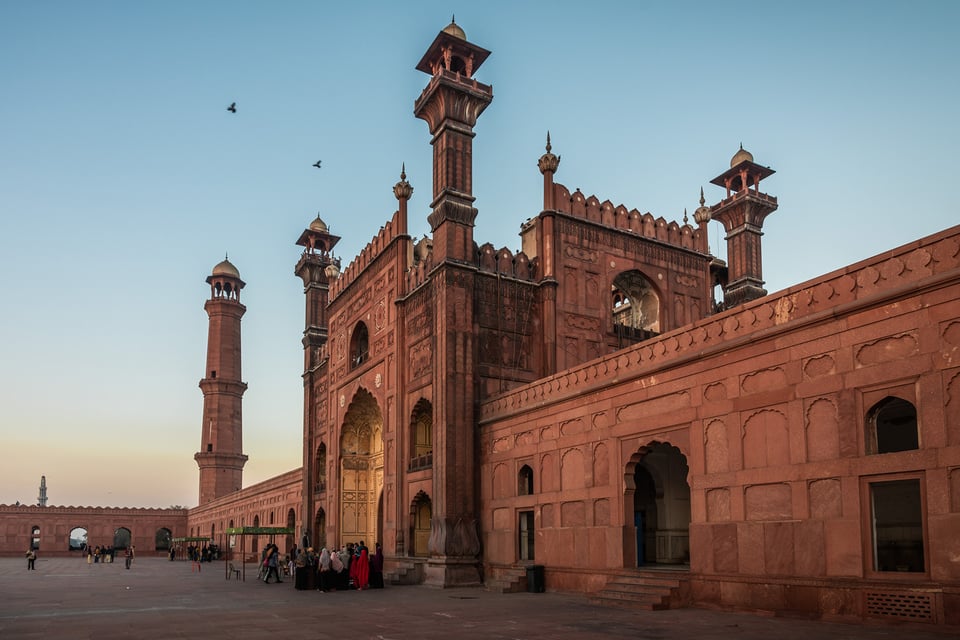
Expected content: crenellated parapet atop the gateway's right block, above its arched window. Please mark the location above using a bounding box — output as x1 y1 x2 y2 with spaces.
553 183 702 250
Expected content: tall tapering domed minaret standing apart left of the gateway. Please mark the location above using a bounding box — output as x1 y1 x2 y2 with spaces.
193 260 247 505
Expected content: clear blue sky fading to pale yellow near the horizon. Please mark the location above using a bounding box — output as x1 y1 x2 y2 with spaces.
0 0 960 507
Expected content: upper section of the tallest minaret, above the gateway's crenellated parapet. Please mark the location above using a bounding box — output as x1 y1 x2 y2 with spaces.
413 16 493 263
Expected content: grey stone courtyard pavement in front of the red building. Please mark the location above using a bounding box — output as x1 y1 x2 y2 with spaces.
0 557 957 640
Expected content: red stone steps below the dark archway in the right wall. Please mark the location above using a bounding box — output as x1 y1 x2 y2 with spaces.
590 570 690 611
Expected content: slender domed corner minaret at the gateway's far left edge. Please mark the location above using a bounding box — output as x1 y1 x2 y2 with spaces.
293 214 340 541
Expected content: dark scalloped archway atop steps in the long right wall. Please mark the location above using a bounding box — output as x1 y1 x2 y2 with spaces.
623 442 690 567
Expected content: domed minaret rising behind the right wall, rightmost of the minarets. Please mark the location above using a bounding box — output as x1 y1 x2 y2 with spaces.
710 145 777 309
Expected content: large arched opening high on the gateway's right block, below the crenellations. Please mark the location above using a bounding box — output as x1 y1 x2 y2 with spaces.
610 270 660 347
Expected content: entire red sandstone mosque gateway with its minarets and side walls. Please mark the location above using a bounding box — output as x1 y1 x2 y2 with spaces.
0 18 960 624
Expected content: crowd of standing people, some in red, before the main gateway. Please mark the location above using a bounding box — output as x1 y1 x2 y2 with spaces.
291 540 383 591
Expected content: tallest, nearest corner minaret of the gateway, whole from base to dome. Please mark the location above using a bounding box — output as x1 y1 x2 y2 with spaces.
413 17 493 587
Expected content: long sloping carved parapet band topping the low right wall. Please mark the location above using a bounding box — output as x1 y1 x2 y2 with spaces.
480 226 960 424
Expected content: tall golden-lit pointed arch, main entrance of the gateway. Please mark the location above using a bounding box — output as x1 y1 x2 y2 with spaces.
338 389 383 546
